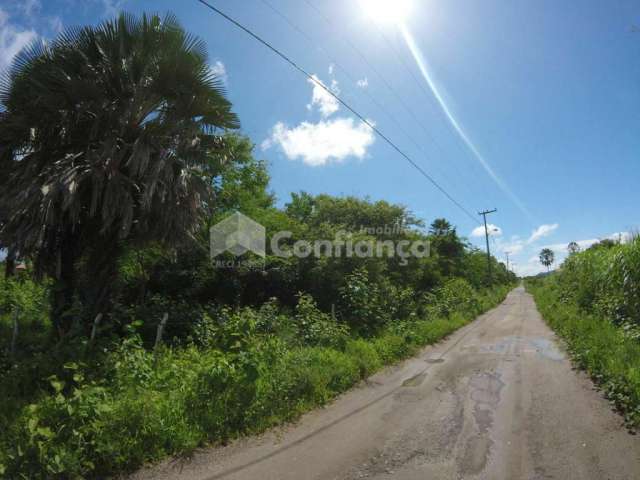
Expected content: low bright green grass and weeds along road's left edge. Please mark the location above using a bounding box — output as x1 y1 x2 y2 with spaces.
0 287 509 479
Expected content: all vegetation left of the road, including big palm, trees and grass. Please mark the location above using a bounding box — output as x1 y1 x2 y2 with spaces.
0 15 515 479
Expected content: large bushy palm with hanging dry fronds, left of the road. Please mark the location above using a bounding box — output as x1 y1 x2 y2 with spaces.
0 14 238 334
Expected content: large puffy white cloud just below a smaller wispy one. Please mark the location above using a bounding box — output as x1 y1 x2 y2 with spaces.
262 118 375 166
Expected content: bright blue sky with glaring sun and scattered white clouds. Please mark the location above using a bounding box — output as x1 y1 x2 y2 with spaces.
0 0 640 275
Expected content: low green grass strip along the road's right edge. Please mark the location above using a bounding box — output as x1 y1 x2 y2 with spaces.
527 278 640 428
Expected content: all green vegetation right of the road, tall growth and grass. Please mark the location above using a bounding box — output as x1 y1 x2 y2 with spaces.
527 238 640 427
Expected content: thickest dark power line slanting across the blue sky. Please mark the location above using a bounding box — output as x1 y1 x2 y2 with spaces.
196 0 479 227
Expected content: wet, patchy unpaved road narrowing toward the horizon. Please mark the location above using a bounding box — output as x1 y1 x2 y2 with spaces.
134 288 640 480
